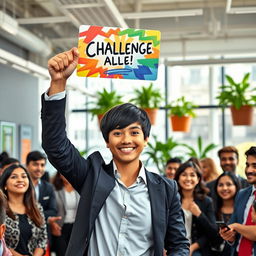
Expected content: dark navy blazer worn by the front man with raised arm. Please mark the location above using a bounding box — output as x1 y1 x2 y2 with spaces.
42 95 189 256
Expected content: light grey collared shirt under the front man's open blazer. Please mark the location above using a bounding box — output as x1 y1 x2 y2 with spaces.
88 164 154 256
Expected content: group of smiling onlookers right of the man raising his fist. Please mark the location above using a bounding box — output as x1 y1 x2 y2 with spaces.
164 146 256 256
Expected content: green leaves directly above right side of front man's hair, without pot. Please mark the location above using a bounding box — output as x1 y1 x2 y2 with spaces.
130 83 163 108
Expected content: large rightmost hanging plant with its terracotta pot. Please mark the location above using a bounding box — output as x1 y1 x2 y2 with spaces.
216 73 256 125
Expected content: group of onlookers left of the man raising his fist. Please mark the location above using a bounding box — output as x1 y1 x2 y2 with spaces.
0 151 79 256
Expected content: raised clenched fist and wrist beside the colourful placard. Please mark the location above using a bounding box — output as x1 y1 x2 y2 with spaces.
48 47 79 96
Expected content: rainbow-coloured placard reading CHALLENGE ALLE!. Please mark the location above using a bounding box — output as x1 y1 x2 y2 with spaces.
77 25 161 80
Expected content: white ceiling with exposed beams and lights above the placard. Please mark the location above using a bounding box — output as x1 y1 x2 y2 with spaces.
0 0 256 66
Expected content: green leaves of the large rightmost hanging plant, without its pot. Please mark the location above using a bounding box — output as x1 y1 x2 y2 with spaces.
216 73 256 109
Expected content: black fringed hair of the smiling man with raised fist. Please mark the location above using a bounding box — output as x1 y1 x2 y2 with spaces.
100 103 151 142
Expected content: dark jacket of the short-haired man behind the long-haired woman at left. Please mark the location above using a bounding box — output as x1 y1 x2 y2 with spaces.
38 180 57 220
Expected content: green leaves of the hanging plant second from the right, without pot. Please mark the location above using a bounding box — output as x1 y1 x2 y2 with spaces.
167 96 197 117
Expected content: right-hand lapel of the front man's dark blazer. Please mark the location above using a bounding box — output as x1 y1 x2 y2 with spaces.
146 171 167 250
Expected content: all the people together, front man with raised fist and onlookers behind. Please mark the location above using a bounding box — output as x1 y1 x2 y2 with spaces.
0 48 256 256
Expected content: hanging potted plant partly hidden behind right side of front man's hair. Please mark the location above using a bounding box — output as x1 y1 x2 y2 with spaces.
130 83 163 125
